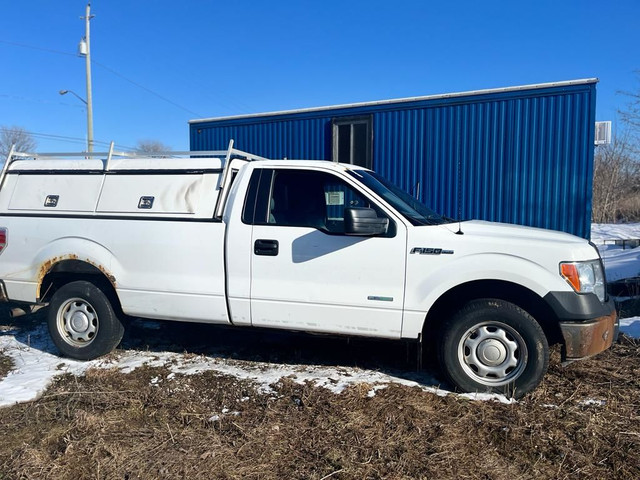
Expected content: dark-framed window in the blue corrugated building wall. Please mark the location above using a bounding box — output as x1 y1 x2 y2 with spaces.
333 115 373 168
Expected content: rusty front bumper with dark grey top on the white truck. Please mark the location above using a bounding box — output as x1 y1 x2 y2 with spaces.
545 292 620 362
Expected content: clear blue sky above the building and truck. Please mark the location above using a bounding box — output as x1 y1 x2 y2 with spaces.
0 0 640 151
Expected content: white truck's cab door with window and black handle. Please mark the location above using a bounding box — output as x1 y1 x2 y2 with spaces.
242 168 406 338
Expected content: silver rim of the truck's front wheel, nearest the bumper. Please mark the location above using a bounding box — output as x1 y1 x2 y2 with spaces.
458 322 528 387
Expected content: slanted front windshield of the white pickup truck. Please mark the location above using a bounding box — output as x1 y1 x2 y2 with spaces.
349 170 454 226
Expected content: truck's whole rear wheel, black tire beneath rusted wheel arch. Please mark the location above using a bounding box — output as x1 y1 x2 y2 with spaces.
47 280 124 360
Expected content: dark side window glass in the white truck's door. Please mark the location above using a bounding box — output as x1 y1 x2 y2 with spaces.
255 169 395 236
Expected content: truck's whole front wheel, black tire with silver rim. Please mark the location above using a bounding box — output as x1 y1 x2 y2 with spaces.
437 299 549 398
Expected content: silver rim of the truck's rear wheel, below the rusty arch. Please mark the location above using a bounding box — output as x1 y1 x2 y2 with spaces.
57 298 98 347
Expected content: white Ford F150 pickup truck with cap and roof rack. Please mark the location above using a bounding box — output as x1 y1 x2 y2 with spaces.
0 145 618 396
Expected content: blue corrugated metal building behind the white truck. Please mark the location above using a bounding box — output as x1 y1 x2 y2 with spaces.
189 79 598 238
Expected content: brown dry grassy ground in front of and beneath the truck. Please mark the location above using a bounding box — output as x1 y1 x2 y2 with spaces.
0 310 640 480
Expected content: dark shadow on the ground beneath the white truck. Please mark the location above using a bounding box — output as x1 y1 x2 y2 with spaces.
0 305 448 389
